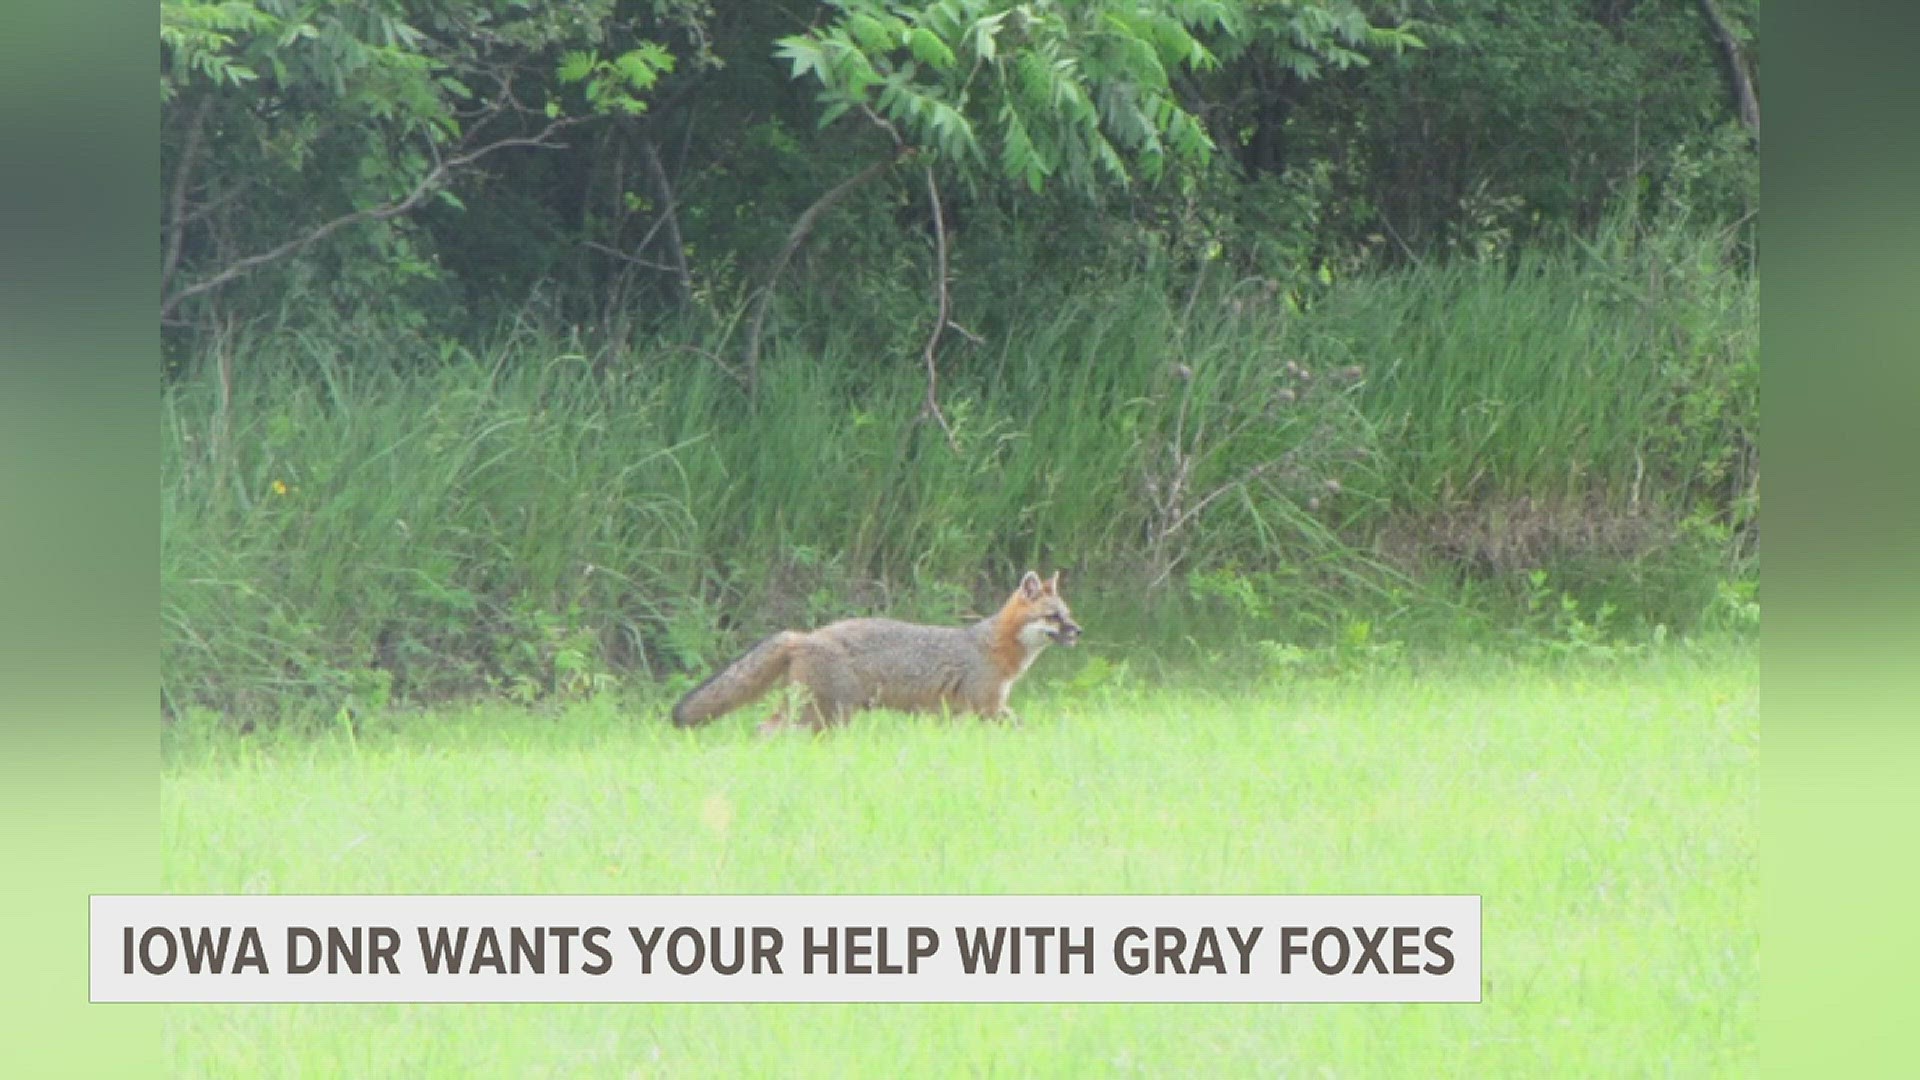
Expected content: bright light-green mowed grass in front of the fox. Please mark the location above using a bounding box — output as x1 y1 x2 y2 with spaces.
163 646 1761 1078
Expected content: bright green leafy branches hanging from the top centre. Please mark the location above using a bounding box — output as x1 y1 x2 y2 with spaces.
778 0 1419 192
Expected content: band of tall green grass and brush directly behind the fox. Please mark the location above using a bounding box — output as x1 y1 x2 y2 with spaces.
161 211 1759 713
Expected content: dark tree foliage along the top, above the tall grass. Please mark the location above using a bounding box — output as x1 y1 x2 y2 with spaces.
161 0 1759 340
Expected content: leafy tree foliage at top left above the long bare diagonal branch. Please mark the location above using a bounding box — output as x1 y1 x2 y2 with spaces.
159 0 672 323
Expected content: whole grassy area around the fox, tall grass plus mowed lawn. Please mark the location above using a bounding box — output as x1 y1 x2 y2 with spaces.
161 208 1759 1078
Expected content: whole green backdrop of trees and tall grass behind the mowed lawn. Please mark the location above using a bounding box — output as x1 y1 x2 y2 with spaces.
159 0 1759 705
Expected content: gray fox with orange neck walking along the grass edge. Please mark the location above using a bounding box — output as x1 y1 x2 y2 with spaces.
674 571 1081 732
